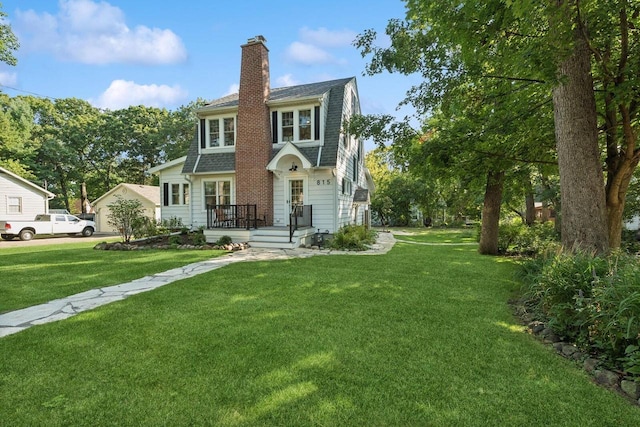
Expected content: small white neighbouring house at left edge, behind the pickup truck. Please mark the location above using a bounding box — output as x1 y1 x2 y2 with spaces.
0 167 55 221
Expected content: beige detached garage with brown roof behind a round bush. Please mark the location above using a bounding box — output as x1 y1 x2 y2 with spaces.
93 183 160 232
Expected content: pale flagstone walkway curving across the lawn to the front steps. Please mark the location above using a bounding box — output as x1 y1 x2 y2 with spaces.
0 233 395 338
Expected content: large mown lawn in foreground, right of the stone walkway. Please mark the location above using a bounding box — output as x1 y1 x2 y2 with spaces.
0 236 640 426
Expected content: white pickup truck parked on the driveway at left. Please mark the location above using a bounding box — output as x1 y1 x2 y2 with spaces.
0 214 96 240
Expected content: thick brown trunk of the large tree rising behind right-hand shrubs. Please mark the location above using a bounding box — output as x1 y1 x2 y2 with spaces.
553 22 609 253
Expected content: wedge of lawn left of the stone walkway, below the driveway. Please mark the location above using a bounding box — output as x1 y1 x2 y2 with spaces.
0 242 223 313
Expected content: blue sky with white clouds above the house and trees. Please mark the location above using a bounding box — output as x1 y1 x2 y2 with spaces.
0 0 418 127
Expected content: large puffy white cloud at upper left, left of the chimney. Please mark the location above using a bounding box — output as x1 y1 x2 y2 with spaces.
15 0 187 64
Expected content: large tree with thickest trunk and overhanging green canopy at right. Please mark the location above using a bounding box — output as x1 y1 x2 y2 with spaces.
356 0 640 251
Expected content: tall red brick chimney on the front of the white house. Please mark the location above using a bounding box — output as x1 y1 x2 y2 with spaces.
235 36 273 225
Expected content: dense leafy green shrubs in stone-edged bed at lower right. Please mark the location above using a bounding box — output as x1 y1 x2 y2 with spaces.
523 253 640 376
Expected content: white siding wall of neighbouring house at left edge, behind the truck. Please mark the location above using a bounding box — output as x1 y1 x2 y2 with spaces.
0 172 49 220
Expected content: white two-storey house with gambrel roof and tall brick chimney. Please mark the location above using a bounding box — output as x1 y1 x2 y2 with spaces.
150 36 373 247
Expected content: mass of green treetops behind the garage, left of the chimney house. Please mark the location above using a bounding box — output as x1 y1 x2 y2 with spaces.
0 93 203 211
